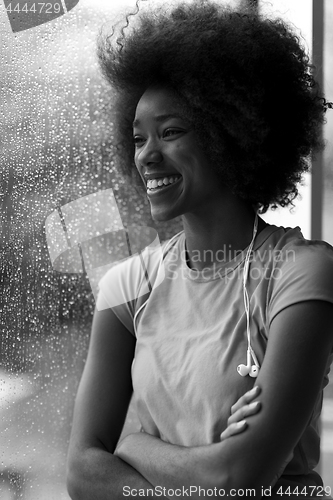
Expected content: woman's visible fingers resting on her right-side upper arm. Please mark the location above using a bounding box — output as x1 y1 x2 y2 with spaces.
220 386 260 441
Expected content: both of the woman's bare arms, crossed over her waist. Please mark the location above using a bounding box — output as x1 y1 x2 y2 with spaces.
68 301 333 500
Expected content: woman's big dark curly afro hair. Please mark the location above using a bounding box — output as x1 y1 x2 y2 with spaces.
98 0 325 213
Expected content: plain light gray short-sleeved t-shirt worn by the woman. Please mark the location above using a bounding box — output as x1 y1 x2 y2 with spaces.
97 226 333 485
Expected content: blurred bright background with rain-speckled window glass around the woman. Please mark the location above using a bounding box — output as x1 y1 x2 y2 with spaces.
0 0 333 500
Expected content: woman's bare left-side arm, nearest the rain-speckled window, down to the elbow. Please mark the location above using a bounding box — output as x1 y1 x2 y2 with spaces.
67 309 161 500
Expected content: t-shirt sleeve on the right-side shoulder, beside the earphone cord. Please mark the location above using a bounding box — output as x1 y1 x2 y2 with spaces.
266 239 333 326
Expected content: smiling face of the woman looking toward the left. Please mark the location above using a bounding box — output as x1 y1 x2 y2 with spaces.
133 87 222 221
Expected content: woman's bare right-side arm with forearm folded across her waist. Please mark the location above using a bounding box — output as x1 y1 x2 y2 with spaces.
118 301 333 498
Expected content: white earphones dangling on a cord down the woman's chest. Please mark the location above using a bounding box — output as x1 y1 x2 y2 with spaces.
237 214 260 378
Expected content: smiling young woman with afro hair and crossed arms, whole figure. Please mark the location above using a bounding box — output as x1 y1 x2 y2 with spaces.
68 1 333 500
